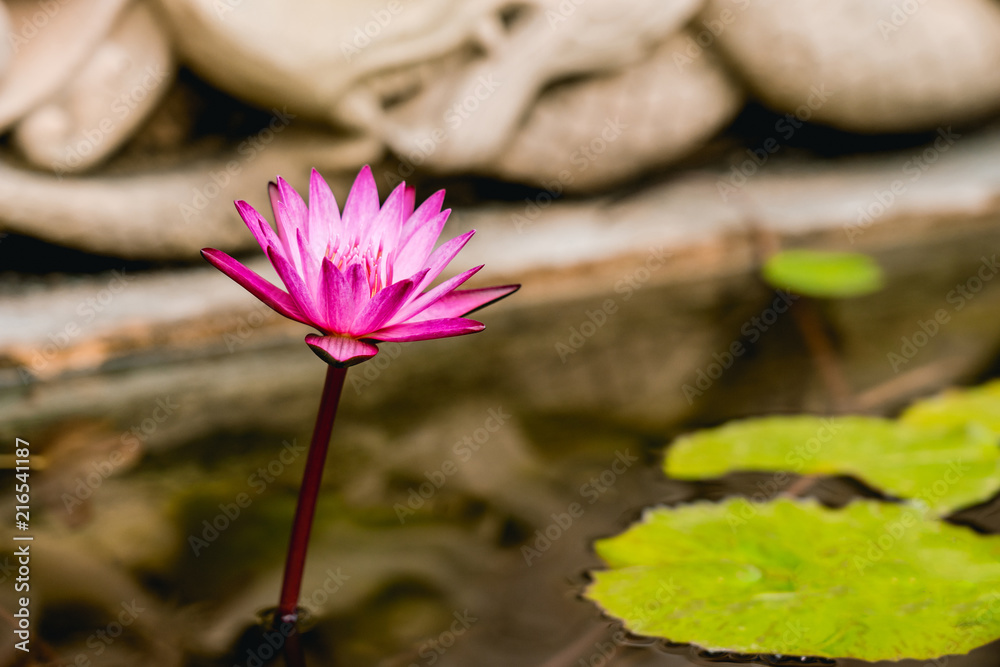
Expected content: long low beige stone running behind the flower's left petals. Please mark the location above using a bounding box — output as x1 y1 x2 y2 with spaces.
0 128 372 261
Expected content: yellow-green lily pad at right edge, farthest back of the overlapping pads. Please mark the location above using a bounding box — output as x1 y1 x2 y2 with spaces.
899 380 1000 437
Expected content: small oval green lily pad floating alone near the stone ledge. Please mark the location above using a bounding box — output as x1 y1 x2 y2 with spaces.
763 250 883 298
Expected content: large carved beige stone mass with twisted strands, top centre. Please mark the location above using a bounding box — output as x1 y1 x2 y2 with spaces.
156 0 720 191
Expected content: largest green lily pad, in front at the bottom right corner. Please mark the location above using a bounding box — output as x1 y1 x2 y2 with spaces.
585 498 1000 661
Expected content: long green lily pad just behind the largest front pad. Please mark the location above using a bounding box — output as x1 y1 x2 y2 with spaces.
664 416 1000 515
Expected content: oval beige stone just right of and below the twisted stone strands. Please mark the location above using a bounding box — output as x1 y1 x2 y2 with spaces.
492 32 743 194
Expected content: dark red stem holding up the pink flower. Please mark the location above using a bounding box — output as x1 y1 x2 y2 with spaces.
275 366 347 644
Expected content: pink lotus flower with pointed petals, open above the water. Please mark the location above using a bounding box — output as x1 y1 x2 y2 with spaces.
201 166 520 366
